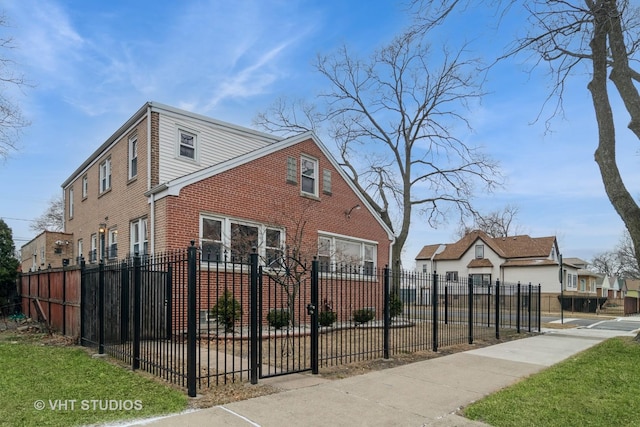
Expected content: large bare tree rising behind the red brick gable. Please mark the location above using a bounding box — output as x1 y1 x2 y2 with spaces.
254 32 501 274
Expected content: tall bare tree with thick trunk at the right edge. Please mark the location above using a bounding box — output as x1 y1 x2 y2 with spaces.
411 0 640 294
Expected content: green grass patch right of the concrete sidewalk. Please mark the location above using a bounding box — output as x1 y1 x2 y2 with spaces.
464 338 640 427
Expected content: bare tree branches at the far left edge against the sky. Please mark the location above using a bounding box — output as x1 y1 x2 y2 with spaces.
0 14 29 159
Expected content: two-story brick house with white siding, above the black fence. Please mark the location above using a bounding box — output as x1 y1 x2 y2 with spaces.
62 102 393 271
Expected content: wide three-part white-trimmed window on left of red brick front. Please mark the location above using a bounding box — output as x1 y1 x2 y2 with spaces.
200 215 284 267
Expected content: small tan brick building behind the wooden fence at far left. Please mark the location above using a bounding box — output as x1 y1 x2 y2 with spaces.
20 231 73 272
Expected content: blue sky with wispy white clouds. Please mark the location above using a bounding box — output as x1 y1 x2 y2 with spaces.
0 0 640 267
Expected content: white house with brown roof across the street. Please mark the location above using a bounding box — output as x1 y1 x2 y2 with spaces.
416 231 578 294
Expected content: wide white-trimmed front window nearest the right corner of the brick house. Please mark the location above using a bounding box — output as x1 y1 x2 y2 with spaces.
318 235 378 275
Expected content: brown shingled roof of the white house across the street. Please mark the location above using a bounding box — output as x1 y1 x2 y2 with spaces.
416 230 556 263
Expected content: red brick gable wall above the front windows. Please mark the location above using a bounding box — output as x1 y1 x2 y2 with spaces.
156 140 389 267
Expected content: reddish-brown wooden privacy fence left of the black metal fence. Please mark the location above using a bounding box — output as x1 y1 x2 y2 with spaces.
19 267 81 337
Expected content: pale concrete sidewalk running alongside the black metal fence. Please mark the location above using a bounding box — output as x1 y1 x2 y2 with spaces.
130 328 635 427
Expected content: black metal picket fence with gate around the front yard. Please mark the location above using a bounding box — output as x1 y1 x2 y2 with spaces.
80 245 540 396
